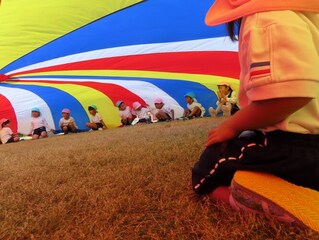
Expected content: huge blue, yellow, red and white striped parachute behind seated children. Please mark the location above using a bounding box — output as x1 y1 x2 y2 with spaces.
0 0 239 133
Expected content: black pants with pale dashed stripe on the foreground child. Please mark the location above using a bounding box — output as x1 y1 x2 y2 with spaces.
192 131 319 194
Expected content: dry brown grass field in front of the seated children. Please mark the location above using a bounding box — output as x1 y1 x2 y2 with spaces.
0 118 319 240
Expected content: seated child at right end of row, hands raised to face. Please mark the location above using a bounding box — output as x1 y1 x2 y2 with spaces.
208 82 239 117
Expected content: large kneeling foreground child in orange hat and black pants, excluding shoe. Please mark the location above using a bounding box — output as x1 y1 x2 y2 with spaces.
192 0 319 225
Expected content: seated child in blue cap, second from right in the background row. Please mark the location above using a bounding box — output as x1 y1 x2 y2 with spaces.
183 92 205 119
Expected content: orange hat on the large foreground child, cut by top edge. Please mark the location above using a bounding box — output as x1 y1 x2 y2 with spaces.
205 0 319 26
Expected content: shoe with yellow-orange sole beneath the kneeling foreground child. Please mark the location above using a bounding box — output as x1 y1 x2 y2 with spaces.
231 171 319 232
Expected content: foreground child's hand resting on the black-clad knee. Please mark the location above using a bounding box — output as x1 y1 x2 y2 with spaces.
205 121 238 147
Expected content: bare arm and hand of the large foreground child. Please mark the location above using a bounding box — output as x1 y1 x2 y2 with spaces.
206 97 311 147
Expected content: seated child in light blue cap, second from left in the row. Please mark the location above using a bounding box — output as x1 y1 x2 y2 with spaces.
28 107 54 139
